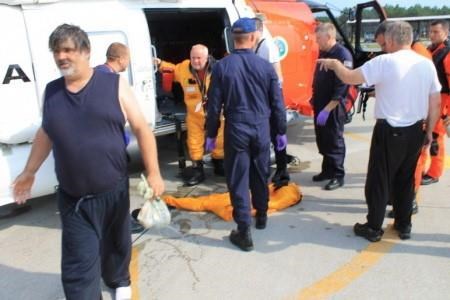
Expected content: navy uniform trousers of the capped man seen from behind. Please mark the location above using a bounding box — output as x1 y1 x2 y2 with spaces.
224 122 270 231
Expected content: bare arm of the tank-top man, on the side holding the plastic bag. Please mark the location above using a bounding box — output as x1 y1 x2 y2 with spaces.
119 78 164 196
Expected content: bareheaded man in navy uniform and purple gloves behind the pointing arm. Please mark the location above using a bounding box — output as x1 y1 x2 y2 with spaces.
312 23 353 190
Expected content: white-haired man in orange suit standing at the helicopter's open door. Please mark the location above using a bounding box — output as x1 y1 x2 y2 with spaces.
155 44 225 186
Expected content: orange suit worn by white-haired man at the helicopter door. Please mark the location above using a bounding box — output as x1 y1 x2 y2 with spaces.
159 59 224 161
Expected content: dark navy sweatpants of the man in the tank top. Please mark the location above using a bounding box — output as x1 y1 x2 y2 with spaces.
58 178 131 300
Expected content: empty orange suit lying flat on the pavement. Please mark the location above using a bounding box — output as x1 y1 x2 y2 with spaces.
162 182 303 221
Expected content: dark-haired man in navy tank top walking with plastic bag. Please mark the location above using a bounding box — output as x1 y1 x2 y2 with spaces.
13 24 164 300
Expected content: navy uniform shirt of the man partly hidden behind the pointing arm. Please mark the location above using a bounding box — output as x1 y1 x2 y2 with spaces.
312 44 353 114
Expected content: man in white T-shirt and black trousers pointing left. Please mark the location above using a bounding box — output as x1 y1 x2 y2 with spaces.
318 21 441 242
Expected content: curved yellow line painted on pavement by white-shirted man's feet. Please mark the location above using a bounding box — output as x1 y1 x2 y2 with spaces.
297 192 421 300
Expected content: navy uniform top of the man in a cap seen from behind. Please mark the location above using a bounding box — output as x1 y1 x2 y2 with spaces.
206 49 286 137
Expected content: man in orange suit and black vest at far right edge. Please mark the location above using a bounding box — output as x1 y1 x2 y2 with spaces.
422 20 450 185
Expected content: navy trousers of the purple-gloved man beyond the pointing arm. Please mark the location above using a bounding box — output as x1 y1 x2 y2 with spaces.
314 104 345 178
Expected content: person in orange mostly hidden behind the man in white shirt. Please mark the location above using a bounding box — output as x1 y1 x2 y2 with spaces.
375 21 432 218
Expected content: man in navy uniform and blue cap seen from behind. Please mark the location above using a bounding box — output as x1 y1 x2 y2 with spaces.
206 18 287 251
